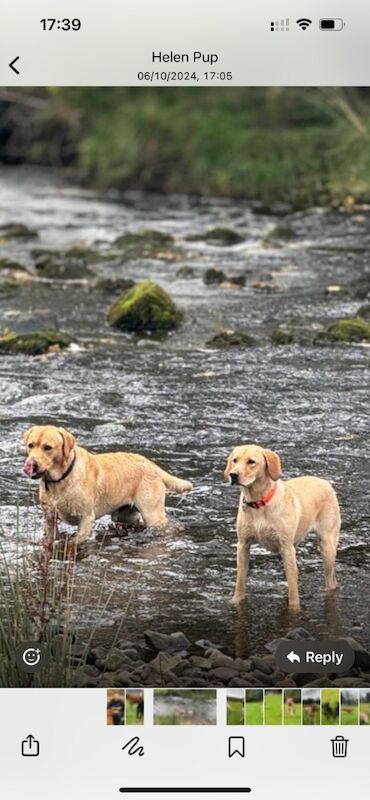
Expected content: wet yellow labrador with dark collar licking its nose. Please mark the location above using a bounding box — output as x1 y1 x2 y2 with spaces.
24 425 193 544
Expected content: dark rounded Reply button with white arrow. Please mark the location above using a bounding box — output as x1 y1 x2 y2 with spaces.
275 639 355 675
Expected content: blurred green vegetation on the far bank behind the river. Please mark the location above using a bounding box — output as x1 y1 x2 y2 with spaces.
0 87 370 208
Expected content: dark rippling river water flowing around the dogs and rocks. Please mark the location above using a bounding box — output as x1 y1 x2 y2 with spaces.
0 168 370 655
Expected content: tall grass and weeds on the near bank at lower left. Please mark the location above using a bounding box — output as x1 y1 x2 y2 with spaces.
0 504 143 688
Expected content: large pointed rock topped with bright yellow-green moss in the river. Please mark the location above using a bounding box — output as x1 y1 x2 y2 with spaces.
108 280 183 332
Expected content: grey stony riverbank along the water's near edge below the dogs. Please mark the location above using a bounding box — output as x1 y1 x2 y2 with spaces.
72 628 370 688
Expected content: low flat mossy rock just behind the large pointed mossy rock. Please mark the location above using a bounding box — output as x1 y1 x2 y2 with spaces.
114 230 176 261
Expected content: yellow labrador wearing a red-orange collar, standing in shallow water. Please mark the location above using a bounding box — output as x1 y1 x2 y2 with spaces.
224 444 340 610
